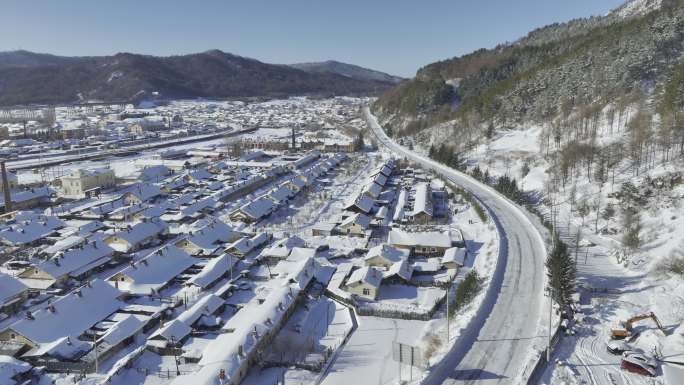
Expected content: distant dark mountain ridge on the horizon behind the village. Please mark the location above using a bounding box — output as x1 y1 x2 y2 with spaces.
0 50 394 105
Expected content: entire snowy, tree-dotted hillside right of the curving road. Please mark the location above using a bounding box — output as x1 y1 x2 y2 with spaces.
373 0 684 385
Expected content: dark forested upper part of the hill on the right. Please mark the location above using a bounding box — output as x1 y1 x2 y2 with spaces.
373 0 684 138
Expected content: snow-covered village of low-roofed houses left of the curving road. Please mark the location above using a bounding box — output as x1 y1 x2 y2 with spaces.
0 98 499 385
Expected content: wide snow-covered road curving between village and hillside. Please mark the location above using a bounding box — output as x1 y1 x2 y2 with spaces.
364 108 548 385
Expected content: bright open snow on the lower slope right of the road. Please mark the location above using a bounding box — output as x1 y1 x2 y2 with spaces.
428 104 684 385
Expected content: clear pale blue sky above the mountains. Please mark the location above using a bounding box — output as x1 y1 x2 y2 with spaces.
0 0 623 76
